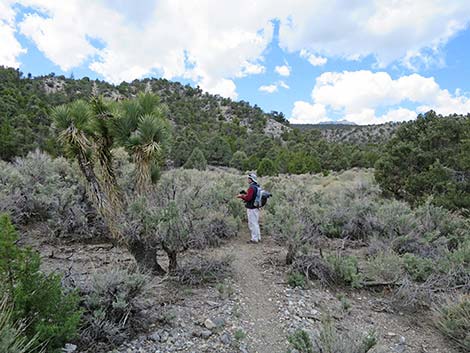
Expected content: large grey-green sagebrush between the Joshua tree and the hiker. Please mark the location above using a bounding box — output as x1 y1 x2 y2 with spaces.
122 169 243 271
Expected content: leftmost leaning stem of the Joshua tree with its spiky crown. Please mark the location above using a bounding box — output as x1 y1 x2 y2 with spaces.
52 100 107 212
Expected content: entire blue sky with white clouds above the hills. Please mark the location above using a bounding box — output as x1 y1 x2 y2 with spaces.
0 0 470 124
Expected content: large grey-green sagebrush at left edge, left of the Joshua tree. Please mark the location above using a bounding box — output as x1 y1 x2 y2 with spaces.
0 151 103 237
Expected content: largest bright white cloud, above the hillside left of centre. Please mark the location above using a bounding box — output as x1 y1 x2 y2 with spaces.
13 0 273 98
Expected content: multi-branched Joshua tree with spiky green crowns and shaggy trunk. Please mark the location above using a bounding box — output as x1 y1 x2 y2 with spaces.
52 94 170 272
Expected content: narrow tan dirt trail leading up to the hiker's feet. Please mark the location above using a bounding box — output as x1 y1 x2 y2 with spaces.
224 234 287 353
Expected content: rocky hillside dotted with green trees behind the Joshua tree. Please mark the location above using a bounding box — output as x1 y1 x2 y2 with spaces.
0 68 386 175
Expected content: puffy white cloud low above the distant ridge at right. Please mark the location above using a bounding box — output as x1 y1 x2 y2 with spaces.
292 70 470 124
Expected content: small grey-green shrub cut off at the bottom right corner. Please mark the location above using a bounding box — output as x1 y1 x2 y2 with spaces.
435 295 470 352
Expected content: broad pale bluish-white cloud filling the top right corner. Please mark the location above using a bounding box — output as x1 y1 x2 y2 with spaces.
279 0 470 66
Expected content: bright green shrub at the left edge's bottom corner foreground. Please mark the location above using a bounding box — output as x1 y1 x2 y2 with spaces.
0 214 81 351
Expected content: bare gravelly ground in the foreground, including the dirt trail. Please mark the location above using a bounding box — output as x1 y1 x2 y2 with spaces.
39 228 458 353
